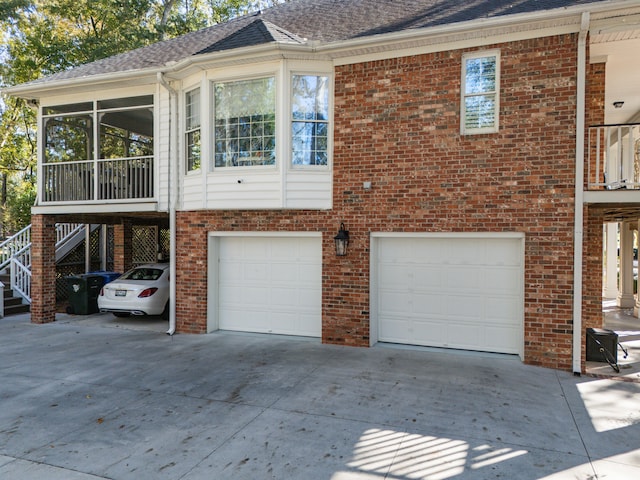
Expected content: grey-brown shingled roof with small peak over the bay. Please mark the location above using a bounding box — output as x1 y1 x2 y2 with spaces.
16 0 602 84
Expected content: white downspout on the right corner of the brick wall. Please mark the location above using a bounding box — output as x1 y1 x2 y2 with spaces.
573 12 591 375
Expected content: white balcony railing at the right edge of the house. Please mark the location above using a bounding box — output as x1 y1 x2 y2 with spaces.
587 123 640 190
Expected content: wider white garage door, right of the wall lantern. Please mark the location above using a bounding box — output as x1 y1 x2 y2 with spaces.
374 235 524 353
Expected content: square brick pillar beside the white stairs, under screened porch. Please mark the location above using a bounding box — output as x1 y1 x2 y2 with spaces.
31 215 56 323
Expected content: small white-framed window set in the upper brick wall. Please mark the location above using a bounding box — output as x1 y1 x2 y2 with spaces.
460 50 500 134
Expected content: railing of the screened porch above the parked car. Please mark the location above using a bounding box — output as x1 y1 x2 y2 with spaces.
40 156 154 203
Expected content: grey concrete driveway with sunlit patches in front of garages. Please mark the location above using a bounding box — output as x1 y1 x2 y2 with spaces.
0 315 640 480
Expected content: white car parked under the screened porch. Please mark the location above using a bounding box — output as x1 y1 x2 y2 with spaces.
98 263 169 318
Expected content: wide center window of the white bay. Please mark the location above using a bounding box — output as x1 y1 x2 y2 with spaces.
213 77 276 167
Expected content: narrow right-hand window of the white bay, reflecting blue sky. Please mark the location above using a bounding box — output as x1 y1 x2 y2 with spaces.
291 75 329 166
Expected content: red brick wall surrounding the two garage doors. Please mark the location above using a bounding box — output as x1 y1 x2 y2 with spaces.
177 35 577 369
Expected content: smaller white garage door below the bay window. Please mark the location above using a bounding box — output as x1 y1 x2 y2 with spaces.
218 236 322 337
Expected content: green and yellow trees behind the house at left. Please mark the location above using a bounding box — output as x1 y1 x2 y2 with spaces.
0 0 287 232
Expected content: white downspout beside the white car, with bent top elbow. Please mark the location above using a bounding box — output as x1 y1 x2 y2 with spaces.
157 72 178 335
